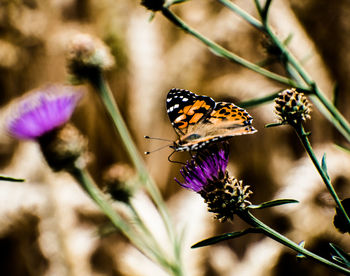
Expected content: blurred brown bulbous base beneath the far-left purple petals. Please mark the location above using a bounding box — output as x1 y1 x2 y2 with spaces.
38 124 88 171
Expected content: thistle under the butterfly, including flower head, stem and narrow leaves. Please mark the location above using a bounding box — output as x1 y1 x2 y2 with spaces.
175 144 350 275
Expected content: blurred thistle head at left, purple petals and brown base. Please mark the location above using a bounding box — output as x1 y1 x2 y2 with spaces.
8 85 87 171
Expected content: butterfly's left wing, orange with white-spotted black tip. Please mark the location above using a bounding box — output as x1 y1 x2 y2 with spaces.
166 88 215 136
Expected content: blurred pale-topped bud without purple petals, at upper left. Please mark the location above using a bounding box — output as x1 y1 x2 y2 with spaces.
67 34 114 80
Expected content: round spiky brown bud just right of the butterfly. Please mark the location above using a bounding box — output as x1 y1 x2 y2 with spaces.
275 88 311 124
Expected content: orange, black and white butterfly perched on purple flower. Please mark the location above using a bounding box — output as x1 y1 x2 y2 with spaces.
166 88 257 151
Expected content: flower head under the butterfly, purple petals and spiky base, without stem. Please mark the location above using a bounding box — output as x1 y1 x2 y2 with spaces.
175 143 252 222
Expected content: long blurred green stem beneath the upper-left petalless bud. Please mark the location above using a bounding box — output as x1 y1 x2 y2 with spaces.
90 72 181 275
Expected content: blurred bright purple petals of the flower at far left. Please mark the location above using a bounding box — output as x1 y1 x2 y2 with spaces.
8 85 82 139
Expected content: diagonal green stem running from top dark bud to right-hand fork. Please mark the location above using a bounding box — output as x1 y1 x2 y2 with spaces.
162 8 297 87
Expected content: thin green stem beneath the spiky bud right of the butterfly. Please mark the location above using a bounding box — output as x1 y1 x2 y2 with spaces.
292 123 350 229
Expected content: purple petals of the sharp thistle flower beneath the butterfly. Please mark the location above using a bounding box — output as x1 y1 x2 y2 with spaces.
175 144 228 192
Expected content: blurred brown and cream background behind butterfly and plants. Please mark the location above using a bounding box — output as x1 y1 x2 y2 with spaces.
0 0 350 276
